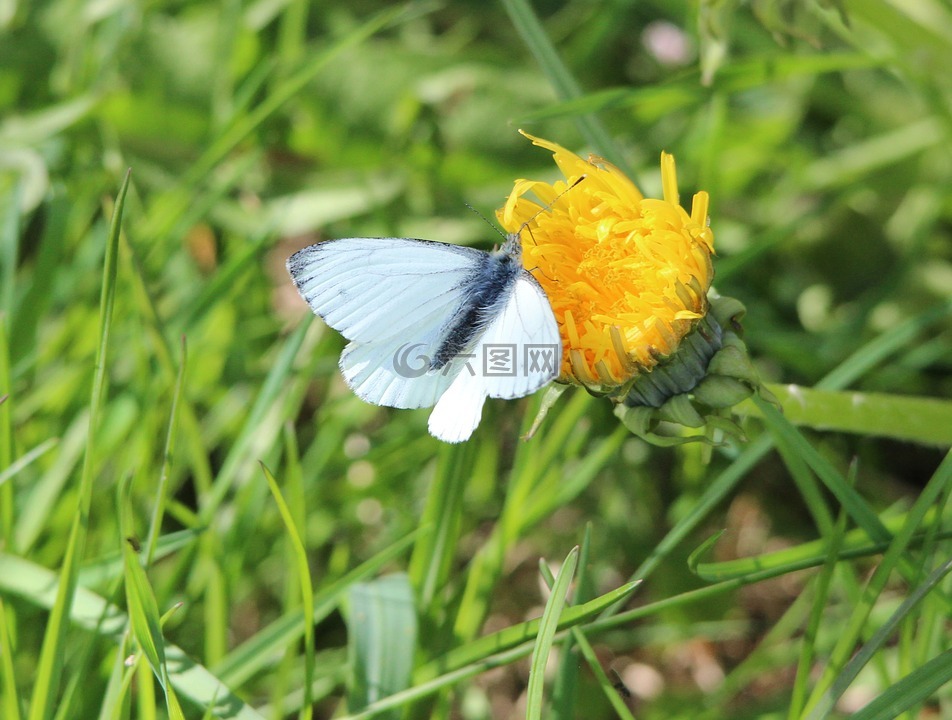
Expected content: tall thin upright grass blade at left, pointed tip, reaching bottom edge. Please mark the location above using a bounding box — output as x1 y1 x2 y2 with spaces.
29 167 131 720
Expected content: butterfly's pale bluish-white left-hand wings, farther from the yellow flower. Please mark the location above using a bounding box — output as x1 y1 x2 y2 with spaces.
287 238 487 408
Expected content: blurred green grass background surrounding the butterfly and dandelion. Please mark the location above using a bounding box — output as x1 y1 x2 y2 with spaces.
0 0 952 720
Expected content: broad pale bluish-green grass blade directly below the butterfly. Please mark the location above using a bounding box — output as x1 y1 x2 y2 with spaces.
347 573 417 718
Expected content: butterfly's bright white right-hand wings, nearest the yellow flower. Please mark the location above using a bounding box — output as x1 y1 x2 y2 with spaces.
429 270 562 442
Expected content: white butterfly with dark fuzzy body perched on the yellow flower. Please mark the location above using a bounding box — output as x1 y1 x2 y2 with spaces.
287 233 562 443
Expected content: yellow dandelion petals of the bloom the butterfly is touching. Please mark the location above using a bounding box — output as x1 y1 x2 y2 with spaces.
497 131 719 396
